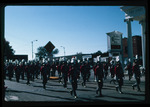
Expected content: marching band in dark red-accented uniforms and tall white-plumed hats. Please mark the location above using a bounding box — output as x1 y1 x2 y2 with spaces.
4 58 144 98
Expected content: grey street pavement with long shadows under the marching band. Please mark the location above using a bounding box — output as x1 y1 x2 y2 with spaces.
5 72 145 103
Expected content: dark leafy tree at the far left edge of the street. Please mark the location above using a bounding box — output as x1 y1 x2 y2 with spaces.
4 39 15 59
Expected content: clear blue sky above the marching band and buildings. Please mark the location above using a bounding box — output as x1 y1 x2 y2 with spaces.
5 6 141 60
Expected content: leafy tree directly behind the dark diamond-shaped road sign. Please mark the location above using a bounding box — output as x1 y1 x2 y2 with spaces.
36 46 59 59
